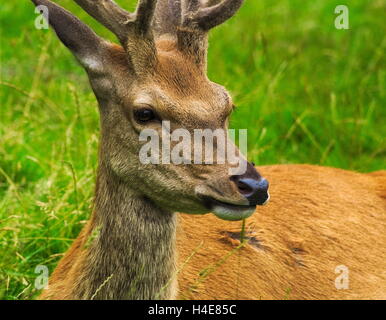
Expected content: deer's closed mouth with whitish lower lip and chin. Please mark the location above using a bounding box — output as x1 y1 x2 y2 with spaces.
204 197 256 221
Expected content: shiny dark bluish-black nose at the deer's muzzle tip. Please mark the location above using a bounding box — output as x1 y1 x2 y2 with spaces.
231 165 269 206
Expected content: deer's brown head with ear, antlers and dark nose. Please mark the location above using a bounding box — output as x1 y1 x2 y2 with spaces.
33 0 269 220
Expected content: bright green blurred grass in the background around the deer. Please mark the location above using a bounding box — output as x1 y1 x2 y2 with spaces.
0 0 386 299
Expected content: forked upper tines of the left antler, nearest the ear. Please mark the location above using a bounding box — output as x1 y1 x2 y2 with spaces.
74 0 157 45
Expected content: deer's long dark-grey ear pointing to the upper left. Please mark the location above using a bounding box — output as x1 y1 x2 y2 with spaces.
32 0 106 72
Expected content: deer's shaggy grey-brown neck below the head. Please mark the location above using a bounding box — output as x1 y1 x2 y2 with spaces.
76 165 176 299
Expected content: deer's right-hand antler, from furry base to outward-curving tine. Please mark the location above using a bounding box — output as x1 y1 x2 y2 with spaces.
175 0 244 69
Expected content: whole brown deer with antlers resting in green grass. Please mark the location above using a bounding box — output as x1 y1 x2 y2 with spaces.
32 0 386 300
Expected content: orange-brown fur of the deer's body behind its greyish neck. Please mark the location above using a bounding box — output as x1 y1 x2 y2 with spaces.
42 165 386 299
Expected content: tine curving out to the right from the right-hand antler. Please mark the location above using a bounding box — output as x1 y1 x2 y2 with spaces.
183 0 244 31
